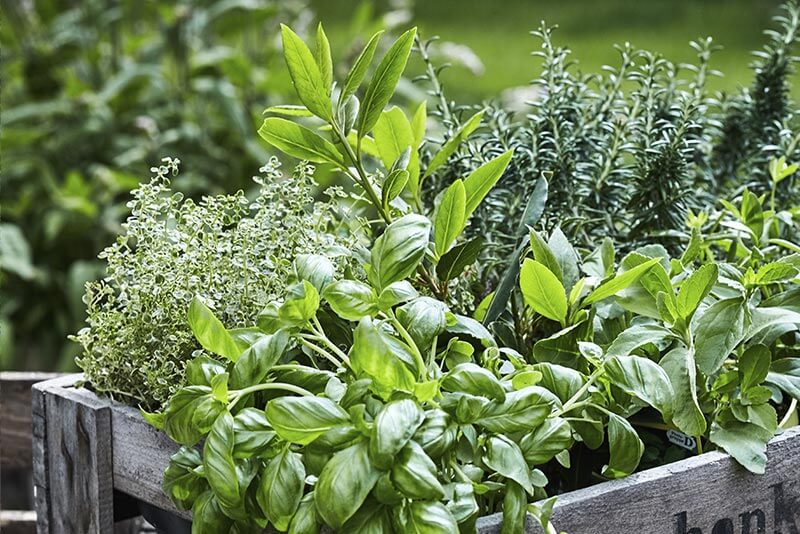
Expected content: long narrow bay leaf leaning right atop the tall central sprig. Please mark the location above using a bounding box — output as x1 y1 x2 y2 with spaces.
356 28 417 137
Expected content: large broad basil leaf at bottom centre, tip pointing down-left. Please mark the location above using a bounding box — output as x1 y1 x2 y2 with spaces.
314 441 381 529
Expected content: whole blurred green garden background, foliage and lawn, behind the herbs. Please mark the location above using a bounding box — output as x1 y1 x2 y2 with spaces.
0 0 798 370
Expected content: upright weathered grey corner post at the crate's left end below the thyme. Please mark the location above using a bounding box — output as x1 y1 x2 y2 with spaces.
37 377 114 534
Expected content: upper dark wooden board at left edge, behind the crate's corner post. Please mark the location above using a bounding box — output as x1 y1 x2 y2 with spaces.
0 371 59 469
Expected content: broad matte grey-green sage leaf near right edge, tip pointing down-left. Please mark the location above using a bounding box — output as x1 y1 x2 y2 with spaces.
694 298 744 375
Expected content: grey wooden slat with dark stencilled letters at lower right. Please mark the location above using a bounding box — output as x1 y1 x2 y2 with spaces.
478 427 800 534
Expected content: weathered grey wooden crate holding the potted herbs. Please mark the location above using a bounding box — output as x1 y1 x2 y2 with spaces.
34 376 800 534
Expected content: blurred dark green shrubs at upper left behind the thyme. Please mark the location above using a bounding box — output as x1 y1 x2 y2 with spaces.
0 0 412 369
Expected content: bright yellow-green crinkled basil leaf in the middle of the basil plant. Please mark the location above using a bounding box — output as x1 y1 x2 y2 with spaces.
350 317 416 399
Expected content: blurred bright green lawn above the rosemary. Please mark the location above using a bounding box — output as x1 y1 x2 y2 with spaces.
313 0 800 101
